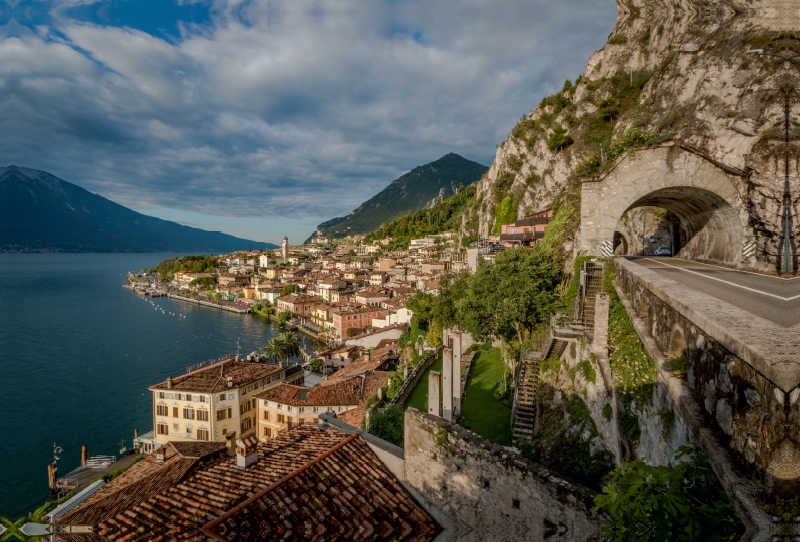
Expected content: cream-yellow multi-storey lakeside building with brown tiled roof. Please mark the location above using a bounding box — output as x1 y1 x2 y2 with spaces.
147 360 290 447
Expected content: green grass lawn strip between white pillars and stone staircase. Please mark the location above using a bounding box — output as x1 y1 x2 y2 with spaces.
456 348 511 446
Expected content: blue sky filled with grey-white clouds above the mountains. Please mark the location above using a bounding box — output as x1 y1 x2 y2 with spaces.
0 0 617 243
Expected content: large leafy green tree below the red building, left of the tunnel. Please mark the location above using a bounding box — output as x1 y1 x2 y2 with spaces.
455 248 561 343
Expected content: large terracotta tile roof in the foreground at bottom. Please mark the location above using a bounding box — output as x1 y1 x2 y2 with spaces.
57 425 440 542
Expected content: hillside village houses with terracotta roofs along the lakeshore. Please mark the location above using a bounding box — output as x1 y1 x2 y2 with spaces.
132 214 552 447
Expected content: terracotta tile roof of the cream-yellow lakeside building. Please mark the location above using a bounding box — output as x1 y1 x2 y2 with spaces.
150 360 283 393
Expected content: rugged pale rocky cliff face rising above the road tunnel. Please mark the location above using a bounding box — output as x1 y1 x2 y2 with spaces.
462 0 800 268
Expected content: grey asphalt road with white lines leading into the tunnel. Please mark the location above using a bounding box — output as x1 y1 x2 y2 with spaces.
628 257 800 328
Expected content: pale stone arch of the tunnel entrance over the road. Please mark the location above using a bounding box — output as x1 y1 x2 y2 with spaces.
581 146 754 267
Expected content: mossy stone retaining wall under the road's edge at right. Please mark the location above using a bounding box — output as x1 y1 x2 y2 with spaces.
617 265 800 494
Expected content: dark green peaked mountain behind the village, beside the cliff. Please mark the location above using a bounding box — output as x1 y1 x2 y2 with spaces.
319 153 488 238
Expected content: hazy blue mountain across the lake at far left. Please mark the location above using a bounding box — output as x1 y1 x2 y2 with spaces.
0 166 275 253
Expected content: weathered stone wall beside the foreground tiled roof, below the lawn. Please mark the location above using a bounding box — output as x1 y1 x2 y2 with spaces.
405 408 604 542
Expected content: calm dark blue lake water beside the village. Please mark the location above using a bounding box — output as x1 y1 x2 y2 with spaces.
0 254 316 518
